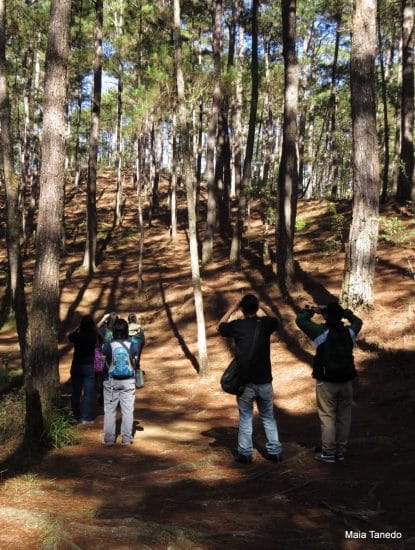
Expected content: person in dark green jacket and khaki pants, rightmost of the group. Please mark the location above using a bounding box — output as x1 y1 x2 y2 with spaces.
296 302 362 464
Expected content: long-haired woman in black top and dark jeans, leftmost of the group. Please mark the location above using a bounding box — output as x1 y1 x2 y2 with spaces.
69 315 102 424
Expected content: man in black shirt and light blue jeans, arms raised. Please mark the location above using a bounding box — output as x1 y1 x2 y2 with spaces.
217 294 282 464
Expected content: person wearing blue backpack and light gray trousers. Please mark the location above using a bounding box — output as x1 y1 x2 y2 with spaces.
102 319 138 445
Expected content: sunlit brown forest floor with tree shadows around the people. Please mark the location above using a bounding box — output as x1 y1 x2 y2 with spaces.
0 175 415 550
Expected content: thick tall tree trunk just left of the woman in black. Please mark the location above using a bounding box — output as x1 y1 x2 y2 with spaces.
26 0 71 442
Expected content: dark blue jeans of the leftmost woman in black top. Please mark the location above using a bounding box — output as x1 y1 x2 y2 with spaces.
71 364 95 420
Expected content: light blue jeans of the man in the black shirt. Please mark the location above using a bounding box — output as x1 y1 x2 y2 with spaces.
237 383 282 456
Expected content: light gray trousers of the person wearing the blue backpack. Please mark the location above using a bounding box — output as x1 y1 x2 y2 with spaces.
104 378 135 445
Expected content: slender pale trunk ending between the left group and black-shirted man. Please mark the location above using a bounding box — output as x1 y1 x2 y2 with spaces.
174 0 208 375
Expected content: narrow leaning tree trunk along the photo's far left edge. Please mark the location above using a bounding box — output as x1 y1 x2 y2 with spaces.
0 0 27 372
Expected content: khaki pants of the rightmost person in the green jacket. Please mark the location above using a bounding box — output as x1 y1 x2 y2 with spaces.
316 380 353 454
